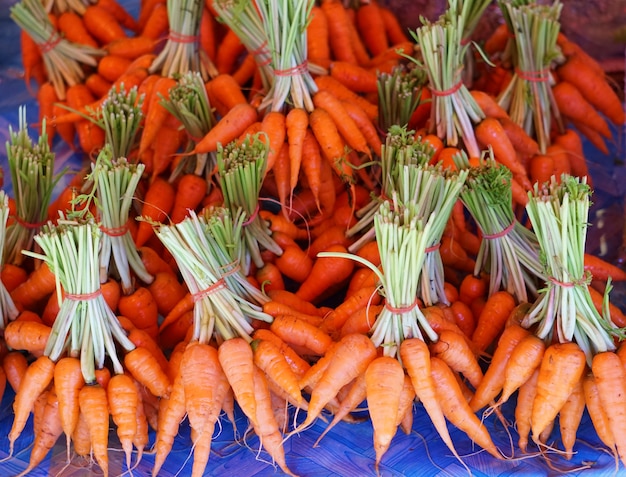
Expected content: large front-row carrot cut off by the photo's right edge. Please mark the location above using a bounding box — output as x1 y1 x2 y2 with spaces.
591 351 626 463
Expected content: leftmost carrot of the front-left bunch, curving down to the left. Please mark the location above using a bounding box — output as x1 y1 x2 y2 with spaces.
9 356 54 455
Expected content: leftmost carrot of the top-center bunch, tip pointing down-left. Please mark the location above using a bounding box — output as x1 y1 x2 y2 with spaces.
191 103 258 154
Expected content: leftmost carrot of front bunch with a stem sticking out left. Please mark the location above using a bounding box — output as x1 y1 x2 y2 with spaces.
293 334 376 433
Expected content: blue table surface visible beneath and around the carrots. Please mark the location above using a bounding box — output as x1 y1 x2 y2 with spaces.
0 0 626 477
